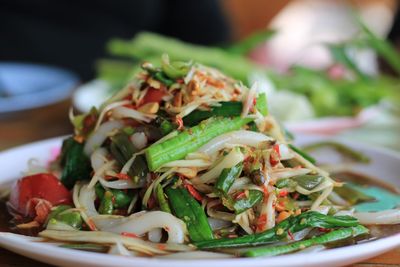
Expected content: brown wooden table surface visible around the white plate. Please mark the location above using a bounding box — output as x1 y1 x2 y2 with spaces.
0 100 400 267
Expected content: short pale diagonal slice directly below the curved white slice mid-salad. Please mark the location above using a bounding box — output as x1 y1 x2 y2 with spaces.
196 149 244 183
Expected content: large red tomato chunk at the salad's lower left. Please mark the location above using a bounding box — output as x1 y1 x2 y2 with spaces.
9 173 72 216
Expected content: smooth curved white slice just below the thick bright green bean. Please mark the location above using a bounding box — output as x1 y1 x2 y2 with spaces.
197 130 273 155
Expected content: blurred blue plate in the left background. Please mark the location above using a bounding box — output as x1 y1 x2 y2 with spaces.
0 62 79 114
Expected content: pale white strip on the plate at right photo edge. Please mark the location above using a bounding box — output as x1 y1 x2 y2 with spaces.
353 209 400 224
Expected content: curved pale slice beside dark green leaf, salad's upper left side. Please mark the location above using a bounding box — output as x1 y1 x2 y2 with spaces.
84 121 124 156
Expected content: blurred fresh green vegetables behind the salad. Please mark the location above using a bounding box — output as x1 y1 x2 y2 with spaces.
99 22 400 117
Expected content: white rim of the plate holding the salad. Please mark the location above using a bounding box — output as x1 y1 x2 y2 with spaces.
0 135 400 267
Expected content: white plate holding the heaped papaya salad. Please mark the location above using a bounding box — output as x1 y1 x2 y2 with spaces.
0 137 400 267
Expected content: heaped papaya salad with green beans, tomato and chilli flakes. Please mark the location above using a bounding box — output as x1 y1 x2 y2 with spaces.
3 55 398 258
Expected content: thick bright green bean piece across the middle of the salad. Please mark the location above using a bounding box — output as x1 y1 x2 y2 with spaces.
146 117 252 171
